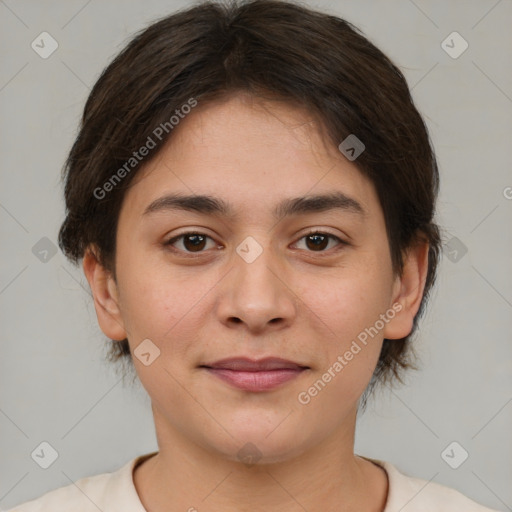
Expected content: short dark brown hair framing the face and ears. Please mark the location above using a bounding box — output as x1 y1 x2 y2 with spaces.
59 0 440 400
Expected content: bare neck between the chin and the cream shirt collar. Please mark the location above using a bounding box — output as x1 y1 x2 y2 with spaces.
133 410 388 512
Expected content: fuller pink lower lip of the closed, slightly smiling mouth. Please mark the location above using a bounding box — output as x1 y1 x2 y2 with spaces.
205 368 306 391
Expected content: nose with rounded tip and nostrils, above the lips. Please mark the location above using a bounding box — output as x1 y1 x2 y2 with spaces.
217 241 297 334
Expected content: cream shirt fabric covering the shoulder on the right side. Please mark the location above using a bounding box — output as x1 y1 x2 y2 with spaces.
368 459 497 512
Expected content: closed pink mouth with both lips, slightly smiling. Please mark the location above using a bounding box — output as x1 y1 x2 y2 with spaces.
200 357 310 392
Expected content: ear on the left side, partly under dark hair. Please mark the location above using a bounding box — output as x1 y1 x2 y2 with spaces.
83 247 127 341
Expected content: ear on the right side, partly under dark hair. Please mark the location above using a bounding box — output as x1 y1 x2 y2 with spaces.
384 240 429 340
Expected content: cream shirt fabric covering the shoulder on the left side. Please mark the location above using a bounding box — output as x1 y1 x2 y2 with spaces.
7 455 154 512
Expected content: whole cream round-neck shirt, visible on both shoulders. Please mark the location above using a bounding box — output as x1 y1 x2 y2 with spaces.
7 452 497 512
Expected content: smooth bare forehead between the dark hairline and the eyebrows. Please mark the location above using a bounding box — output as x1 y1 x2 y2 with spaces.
123 95 379 223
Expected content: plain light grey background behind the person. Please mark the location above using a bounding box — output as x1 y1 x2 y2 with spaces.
0 0 512 511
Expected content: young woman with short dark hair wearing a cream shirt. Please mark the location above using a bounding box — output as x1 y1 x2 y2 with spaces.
8 0 500 512
